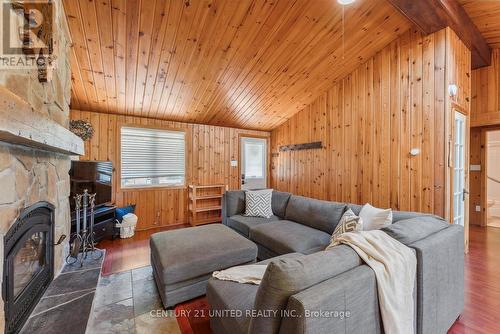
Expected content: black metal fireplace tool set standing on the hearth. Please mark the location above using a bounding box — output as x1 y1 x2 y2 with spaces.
66 189 103 267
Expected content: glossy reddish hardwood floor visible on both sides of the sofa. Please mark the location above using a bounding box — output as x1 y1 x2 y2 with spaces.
99 225 500 334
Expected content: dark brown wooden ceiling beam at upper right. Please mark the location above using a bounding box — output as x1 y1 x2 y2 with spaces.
389 0 491 69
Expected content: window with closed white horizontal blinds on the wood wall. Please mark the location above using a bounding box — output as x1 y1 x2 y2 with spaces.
121 127 186 188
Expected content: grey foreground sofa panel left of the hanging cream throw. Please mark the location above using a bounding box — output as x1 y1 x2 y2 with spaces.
280 265 382 334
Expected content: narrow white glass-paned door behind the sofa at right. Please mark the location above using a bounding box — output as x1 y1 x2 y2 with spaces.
453 111 467 226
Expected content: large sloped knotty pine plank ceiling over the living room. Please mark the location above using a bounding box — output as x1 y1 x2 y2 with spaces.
64 0 410 130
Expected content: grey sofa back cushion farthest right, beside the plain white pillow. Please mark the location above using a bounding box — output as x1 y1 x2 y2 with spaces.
382 215 449 245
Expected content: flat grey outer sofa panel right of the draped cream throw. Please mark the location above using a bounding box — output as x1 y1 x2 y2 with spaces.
409 225 464 334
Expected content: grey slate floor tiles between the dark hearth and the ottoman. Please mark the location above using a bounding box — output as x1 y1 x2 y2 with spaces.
86 266 181 334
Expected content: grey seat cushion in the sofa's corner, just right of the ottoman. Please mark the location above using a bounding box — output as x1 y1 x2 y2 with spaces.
250 220 330 254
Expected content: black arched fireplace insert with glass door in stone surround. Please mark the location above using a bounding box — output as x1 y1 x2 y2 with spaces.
2 202 54 334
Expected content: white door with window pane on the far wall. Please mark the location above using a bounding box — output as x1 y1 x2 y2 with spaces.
240 137 267 190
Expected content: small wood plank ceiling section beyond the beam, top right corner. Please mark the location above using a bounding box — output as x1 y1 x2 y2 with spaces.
458 0 500 49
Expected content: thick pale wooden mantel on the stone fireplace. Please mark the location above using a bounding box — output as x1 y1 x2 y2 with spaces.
0 87 85 155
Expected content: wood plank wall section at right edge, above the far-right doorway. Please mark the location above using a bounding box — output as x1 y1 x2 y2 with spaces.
471 49 500 127
